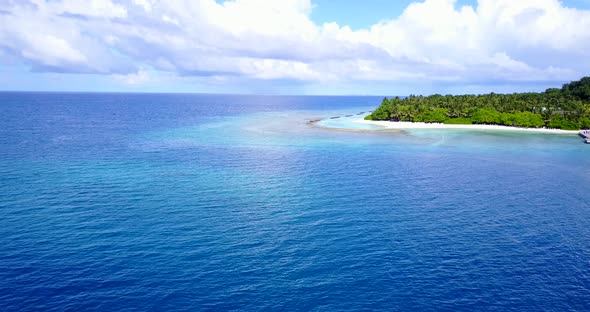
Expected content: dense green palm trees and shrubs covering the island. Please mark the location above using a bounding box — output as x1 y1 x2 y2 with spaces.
365 77 590 130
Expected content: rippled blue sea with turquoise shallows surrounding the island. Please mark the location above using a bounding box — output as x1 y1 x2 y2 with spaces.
0 93 590 311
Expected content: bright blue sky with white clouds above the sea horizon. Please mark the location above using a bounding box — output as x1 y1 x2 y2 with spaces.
0 0 590 95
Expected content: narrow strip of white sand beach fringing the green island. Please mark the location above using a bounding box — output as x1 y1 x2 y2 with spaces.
352 118 579 134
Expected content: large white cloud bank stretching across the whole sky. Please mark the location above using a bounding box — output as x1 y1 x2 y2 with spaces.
0 0 590 89
